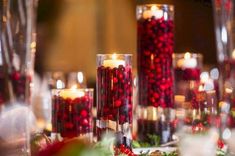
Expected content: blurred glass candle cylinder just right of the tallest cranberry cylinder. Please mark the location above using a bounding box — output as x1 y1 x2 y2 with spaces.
173 52 204 128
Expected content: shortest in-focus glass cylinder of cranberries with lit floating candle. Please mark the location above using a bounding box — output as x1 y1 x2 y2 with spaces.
52 88 93 141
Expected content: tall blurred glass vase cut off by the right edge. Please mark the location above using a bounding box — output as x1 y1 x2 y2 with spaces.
213 0 235 129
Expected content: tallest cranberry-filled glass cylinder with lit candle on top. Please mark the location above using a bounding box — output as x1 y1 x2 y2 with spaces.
137 4 174 143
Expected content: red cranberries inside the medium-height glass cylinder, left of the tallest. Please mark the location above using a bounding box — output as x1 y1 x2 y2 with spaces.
97 65 132 145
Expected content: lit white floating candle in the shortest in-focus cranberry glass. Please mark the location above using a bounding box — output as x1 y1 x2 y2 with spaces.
60 89 85 99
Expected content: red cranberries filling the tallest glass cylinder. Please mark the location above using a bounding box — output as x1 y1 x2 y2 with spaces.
137 16 174 108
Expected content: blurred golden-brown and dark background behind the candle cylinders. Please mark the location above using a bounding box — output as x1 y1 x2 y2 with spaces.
36 0 216 80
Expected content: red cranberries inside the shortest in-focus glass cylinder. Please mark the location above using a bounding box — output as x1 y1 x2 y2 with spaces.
52 95 93 138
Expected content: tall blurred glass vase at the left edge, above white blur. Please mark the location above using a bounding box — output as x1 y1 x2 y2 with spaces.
0 0 37 103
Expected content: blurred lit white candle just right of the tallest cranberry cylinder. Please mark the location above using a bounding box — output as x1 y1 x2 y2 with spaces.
177 52 197 68
